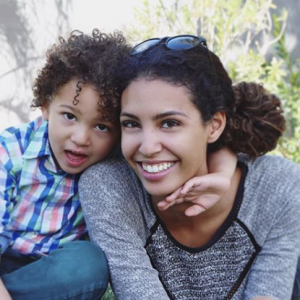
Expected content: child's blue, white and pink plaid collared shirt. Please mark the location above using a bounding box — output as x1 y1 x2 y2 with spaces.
0 117 86 256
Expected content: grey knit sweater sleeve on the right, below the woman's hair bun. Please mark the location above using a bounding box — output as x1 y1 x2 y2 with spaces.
240 156 300 300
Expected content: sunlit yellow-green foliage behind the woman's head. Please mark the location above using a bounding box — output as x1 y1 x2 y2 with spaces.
126 0 300 163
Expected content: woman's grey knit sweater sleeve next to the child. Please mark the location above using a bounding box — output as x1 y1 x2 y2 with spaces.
79 159 169 300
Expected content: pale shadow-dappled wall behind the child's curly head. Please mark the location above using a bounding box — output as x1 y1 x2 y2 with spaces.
0 0 139 131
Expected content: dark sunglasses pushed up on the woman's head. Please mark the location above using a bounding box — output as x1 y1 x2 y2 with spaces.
130 34 207 55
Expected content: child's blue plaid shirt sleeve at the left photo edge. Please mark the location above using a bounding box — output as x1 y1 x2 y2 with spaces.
0 143 16 253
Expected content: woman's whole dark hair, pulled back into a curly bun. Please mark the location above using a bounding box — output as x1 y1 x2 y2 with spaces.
121 43 285 158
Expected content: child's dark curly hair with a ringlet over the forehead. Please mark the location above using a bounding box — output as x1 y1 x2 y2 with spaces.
31 29 130 120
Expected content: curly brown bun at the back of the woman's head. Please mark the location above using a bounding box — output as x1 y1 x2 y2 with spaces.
227 82 285 157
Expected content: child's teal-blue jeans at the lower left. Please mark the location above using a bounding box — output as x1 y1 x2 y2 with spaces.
0 241 108 300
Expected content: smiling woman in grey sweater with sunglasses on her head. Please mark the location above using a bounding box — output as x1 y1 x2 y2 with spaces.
80 35 300 300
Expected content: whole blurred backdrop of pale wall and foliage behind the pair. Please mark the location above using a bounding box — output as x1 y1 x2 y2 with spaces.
0 0 300 163
